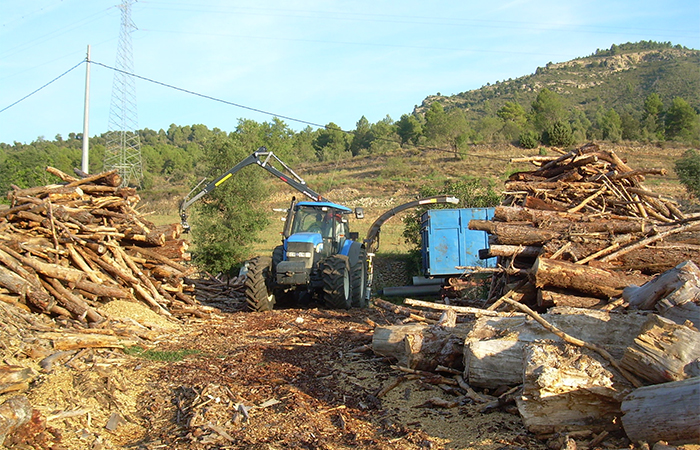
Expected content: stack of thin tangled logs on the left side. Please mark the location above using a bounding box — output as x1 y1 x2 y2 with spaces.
0 167 196 324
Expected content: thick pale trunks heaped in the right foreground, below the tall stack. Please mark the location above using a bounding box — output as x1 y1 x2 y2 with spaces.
372 261 700 448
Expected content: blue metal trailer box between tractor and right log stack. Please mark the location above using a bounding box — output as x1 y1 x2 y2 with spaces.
421 208 496 277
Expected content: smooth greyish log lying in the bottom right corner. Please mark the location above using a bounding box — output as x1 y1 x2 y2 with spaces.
622 377 700 445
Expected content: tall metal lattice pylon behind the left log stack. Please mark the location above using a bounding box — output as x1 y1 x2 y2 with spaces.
104 0 143 186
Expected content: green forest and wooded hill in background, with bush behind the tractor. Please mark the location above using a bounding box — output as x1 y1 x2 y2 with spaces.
0 42 700 270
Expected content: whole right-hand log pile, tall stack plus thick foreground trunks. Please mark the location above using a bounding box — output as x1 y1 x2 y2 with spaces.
373 144 700 448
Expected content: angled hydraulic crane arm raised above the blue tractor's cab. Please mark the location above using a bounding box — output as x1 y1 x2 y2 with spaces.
180 147 328 232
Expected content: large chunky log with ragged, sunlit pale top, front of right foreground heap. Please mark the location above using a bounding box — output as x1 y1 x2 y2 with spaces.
516 341 633 435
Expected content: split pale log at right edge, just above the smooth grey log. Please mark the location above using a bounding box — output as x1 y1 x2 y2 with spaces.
620 314 700 383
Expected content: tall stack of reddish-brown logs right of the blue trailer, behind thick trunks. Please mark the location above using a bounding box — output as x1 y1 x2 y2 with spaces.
469 144 700 309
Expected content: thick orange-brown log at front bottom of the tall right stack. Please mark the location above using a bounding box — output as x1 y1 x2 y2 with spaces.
532 257 648 298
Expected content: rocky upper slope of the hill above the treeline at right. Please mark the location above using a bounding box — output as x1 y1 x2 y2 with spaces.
415 42 700 118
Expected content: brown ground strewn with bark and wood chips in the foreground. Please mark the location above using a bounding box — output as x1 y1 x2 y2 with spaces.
20 302 545 450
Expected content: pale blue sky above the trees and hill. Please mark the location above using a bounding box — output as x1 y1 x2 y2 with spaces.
0 0 700 143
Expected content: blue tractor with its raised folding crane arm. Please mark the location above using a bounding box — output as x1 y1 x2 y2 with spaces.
180 147 368 311
